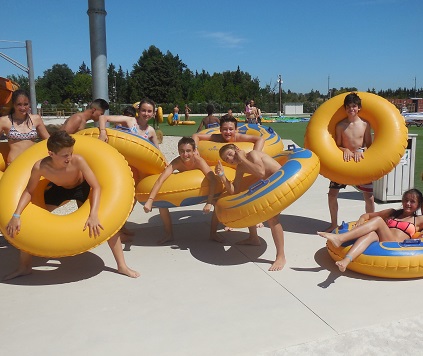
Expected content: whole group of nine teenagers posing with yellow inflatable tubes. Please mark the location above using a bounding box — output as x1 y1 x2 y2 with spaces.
0 90 423 280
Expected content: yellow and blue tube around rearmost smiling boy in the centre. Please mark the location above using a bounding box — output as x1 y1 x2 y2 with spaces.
198 124 283 168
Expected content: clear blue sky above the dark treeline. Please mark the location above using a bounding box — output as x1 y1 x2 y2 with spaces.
0 0 423 93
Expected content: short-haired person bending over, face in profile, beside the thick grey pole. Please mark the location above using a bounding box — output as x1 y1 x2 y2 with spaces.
61 99 109 134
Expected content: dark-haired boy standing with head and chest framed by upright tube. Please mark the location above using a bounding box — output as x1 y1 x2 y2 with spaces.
325 93 375 232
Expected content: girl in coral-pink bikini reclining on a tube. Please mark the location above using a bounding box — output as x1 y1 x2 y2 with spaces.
317 189 423 272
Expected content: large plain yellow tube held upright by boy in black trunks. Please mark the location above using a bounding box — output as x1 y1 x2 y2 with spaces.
0 135 134 257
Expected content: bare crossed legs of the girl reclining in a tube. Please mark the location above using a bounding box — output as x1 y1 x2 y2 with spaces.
317 216 391 272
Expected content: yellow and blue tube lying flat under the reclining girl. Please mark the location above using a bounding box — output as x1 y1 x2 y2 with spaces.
326 221 423 278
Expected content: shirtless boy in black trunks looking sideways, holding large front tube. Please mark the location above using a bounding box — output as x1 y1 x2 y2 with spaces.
4 131 139 280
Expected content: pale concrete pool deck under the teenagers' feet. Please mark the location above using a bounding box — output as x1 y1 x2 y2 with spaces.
0 135 423 356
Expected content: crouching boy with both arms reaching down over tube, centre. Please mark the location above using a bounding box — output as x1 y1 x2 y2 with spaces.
144 137 216 244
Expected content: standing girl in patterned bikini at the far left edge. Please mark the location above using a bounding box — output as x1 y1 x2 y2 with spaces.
0 89 50 165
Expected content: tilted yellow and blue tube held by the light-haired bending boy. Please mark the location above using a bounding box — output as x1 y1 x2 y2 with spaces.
215 148 320 228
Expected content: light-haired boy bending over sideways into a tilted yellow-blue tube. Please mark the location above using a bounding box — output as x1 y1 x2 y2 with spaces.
215 144 286 271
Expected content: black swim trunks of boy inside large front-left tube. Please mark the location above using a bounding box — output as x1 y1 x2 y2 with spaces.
44 180 91 206
